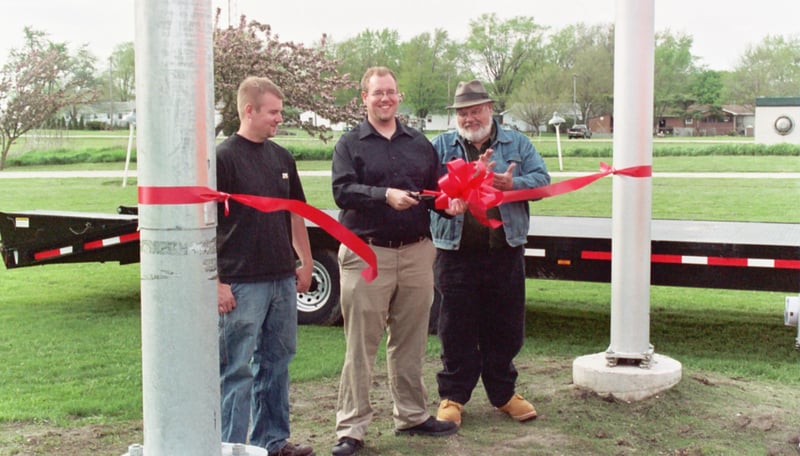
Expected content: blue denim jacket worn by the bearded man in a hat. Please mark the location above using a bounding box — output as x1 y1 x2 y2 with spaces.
431 119 550 250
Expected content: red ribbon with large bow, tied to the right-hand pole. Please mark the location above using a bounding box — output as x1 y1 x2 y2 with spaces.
432 159 653 228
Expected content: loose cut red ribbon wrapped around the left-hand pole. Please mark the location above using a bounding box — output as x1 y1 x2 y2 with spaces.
139 186 378 282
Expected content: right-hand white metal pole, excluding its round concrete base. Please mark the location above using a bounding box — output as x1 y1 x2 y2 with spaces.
607 0 655 364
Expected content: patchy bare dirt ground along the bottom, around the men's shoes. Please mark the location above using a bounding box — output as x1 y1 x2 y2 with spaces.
0 357 800 456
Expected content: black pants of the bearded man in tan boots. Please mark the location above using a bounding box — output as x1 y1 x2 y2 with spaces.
434 246 525 407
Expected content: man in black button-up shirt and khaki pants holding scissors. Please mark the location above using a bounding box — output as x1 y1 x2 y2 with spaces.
332 67 466 455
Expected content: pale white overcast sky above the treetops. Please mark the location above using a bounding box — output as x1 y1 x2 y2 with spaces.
0 0 800 70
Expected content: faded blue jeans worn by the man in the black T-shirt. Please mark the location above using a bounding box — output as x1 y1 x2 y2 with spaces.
219 277 297 452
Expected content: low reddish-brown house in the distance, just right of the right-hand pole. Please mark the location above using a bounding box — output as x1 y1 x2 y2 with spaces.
656 105 755 136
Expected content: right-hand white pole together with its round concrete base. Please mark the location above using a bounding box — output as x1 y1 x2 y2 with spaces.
572 0 681 401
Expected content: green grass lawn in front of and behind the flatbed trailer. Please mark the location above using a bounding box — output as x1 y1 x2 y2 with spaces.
0 145 800 454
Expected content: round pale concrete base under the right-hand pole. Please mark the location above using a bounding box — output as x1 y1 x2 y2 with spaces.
572 352 681 401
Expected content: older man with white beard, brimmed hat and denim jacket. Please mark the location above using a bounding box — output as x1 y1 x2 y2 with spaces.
431 80 550 432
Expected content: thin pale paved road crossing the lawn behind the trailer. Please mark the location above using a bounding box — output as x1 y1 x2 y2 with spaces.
0 171 800 180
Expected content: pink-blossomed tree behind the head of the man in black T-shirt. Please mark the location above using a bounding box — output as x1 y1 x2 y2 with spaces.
214 10 361 140
